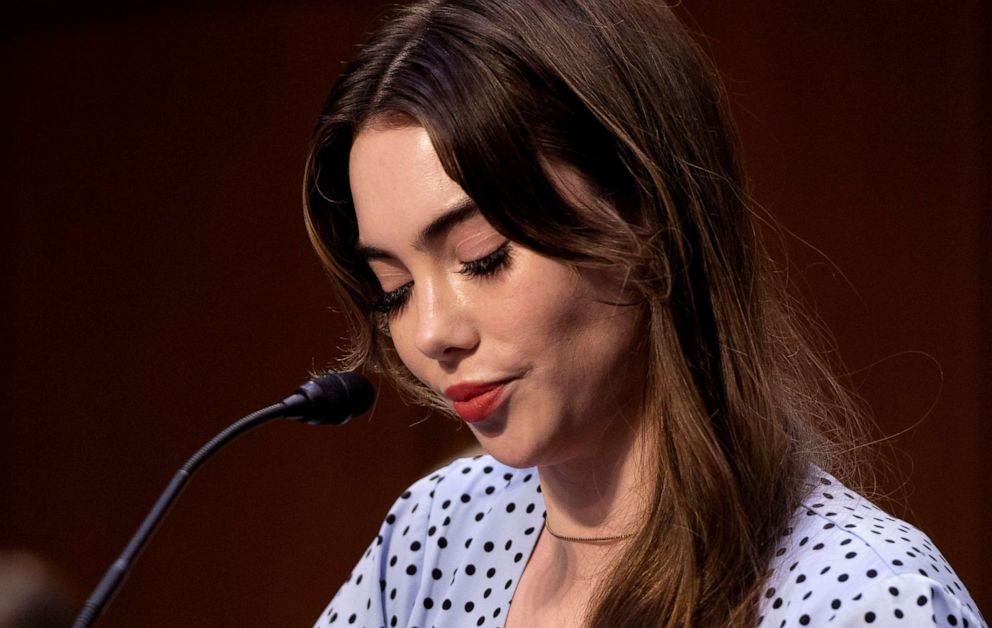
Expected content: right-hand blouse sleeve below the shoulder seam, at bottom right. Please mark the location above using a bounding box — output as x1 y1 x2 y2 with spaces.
812 573 987 628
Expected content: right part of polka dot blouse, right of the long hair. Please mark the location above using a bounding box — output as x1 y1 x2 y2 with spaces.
759 470 986 627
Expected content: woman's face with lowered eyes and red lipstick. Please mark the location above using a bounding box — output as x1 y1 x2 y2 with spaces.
349 126 644 467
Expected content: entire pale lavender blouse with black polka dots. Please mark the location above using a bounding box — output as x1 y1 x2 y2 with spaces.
316 456 987 628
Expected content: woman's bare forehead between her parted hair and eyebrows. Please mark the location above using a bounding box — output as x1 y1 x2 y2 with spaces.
348 126 466 245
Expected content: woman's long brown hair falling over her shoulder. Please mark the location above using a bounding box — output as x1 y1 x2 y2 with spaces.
304 0 868 627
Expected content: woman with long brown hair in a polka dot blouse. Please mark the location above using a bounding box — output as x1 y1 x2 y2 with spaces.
305 0 984 627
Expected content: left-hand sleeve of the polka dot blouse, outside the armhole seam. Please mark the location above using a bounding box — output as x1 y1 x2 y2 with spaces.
314 475 438 628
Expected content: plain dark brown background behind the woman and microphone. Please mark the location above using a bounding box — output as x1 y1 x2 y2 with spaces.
0 0 992 627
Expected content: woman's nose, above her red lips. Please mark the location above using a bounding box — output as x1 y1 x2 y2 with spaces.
414 280 479 362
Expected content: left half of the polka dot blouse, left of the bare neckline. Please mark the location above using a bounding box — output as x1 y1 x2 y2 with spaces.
317 456 544 626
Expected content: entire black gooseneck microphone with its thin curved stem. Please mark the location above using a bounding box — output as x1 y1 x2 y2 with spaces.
72 372 375 628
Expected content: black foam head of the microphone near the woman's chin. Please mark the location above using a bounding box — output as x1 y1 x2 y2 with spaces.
294 371 375 425
